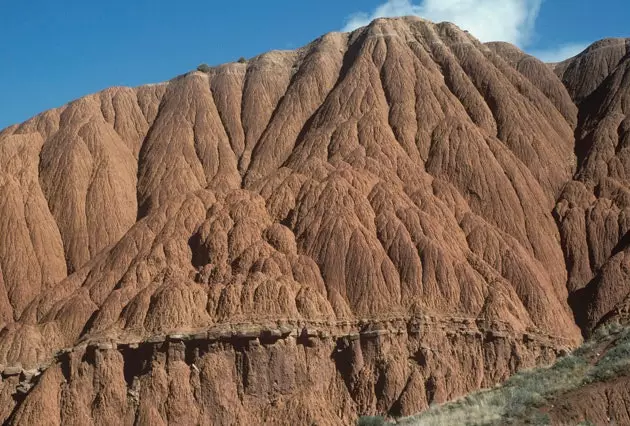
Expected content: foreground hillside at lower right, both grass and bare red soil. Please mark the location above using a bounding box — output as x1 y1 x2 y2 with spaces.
392 323 630 426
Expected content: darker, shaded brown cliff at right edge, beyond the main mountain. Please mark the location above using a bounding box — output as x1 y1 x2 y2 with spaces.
554 39 630 334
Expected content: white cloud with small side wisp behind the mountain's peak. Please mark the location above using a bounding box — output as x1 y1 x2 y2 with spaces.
343 0 586 62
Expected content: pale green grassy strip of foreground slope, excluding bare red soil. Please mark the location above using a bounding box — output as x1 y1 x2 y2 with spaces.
359 324 630 426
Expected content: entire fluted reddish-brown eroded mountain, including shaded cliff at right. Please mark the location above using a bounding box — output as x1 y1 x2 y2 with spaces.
0 14 630 425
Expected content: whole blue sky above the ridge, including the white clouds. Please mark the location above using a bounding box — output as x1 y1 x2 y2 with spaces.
0 0 630 128
